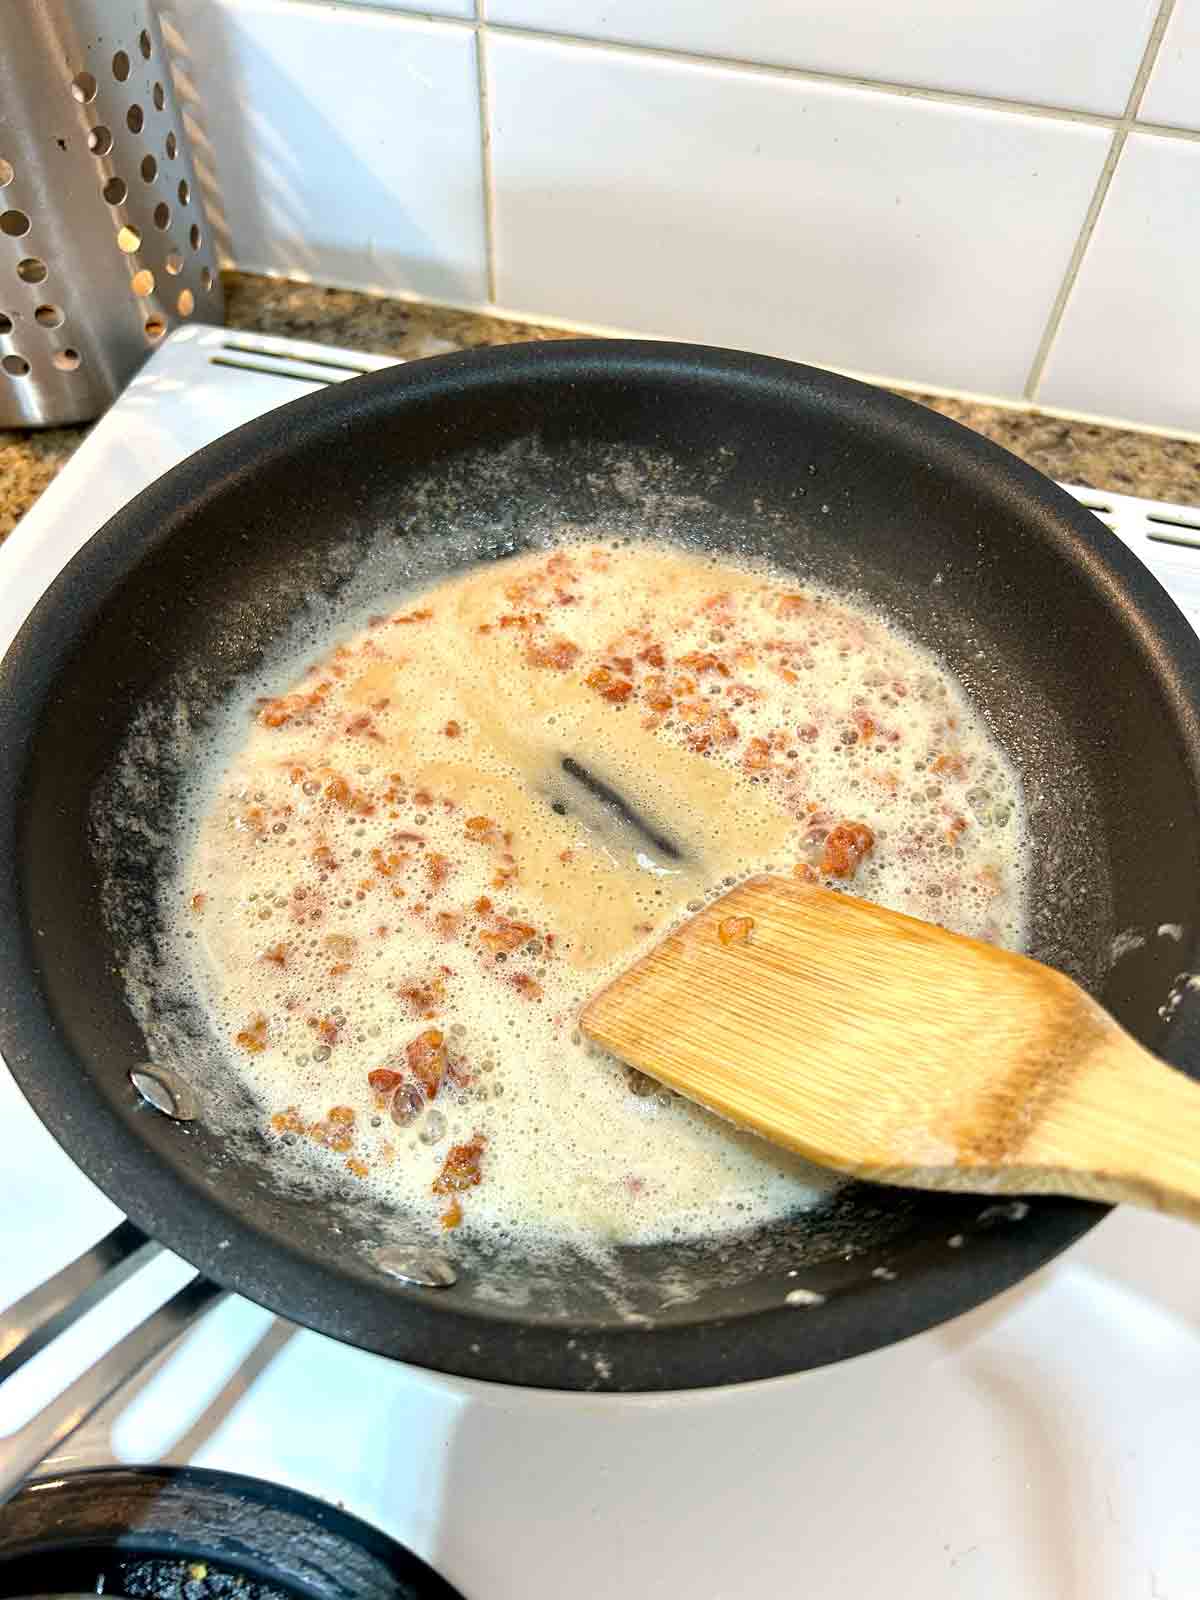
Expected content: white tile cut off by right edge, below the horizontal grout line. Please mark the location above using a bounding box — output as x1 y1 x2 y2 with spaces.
1038 133 1200 430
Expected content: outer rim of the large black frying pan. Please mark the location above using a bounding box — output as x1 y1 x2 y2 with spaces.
0 339 1200 1394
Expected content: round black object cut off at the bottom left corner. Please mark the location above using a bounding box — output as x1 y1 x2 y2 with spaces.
0 1467 462 1600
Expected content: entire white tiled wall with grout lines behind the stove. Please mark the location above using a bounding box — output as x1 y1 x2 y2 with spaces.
168 0 1200 432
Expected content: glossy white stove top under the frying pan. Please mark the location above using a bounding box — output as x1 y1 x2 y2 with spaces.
0 328 1200 1600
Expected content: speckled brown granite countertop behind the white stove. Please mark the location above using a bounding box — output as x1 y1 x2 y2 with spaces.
0 272 1200 539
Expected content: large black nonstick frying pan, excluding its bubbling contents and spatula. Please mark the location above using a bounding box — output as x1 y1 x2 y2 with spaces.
0 341 1200 1390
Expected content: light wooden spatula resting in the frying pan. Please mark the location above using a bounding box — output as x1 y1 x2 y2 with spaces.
582 877 1200 1221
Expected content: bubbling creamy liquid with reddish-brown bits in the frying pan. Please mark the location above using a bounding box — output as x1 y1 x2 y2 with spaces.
176 542 1026 1245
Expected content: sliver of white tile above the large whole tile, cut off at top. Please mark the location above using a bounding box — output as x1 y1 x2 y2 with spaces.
488 0 1157 114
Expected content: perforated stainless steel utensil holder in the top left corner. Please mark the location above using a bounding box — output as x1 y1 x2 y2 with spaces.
0 0 224 427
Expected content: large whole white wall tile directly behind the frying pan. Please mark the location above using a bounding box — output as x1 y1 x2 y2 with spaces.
490 35 1109 395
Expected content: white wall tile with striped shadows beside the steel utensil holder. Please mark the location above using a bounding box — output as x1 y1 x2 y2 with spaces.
173 0 486 302
